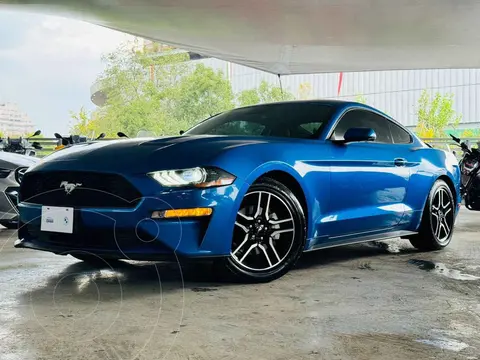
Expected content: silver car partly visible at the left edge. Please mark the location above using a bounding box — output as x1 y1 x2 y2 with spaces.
0 151 39 229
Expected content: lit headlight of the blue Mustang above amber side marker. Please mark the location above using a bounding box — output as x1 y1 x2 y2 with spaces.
148 167 235 188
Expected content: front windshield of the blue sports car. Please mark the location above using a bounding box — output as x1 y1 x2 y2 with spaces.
185 102 335 139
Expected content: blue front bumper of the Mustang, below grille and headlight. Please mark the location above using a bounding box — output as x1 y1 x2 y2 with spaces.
15 184 244 261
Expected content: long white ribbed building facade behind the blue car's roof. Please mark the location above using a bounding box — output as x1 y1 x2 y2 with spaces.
201 59 480 129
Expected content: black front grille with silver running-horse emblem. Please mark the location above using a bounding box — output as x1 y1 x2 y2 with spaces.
19 171 141 208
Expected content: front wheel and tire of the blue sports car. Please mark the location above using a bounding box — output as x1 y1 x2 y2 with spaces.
222 178 306 283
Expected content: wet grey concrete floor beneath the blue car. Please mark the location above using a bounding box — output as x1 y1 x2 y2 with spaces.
0 209 480 360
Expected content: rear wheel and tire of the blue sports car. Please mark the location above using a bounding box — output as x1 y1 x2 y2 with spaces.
409 180 455 251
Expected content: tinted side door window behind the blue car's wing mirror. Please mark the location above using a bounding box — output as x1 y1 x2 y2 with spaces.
332 110 393 143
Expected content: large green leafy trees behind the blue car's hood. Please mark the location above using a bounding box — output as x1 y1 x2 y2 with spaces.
71 41 294 137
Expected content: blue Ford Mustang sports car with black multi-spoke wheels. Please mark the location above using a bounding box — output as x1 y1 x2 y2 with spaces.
15 101 460 281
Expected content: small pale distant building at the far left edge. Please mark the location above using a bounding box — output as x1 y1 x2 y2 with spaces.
0 103 35 137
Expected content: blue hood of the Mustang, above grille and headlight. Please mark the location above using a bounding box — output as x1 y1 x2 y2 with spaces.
31 135 274 173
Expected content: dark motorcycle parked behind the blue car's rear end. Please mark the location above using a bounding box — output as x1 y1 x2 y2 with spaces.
450 134 480 211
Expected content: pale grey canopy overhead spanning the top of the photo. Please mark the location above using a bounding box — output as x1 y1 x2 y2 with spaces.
0 0 480 75
